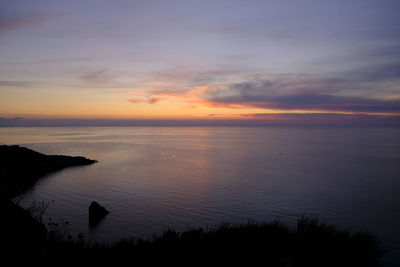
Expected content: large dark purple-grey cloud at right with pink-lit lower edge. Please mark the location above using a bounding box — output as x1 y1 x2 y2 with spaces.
203 63 400 113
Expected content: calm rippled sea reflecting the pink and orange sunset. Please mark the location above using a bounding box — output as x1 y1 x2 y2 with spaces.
0 127 400 262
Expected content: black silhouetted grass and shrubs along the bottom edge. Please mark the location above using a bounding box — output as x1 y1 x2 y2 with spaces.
36 217 384 267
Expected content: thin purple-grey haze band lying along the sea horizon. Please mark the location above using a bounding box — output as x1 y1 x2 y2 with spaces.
0 114 400 127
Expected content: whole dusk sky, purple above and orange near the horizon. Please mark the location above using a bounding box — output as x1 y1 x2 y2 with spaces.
0 0 400 125
